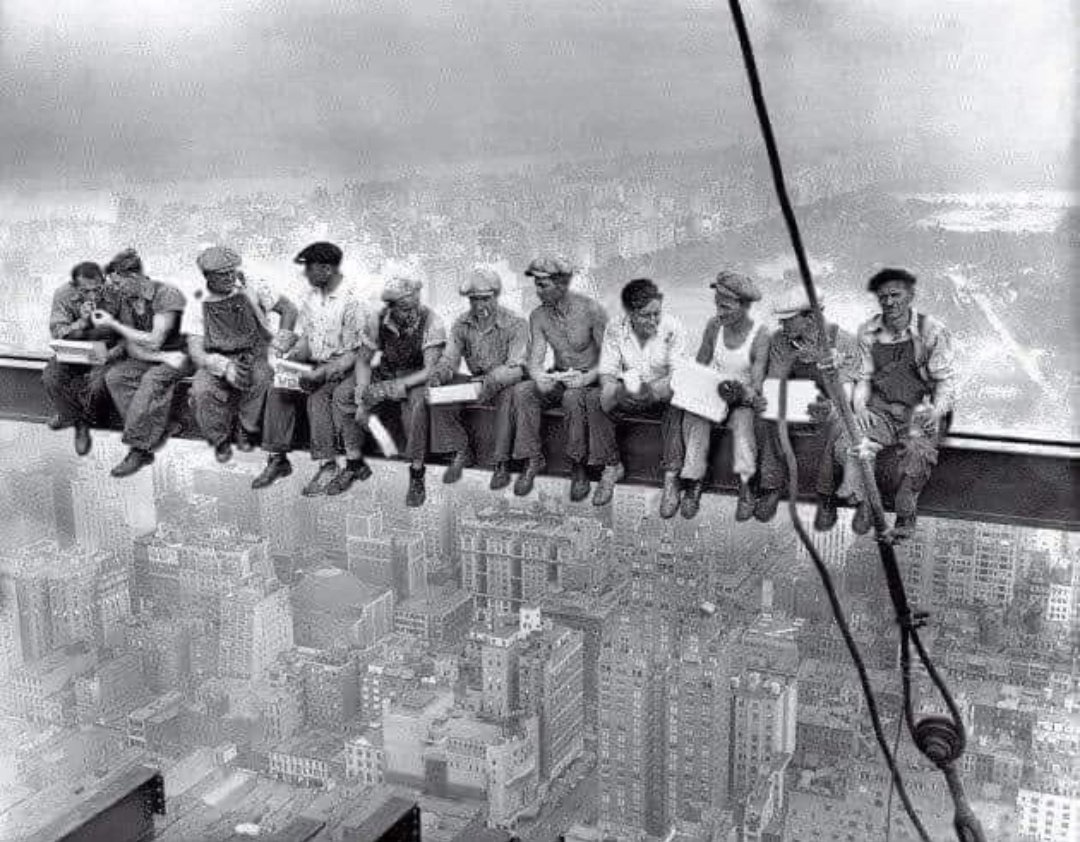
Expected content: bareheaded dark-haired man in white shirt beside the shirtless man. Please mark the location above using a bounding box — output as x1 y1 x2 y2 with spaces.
593 277 686 509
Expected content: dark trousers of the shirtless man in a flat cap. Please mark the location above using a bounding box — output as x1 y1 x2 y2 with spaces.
514 380 615 465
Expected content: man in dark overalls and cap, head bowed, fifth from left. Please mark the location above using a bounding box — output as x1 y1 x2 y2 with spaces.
343 277 446 507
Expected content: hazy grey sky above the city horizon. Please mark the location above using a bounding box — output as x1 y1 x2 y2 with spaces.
0 0 1077 186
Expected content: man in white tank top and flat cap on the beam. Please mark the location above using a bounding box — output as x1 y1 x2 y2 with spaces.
681 271 769 521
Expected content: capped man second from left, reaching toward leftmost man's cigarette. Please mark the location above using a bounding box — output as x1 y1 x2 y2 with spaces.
91 248 192 477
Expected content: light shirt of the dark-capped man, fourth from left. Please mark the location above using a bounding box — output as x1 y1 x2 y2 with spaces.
296 281 376 363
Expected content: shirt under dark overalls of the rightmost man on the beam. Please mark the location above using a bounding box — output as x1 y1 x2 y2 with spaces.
859 309 956 410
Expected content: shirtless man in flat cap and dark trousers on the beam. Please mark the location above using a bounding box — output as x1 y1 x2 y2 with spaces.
514 258 611 502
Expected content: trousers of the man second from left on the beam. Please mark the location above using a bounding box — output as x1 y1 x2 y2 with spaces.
105 358 187 450
